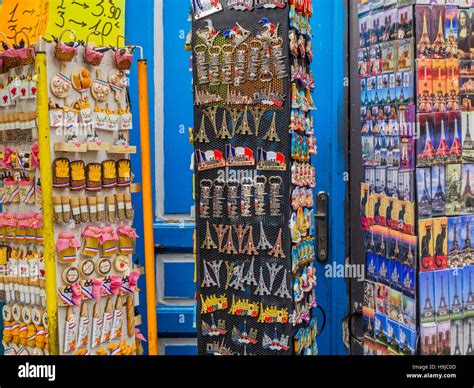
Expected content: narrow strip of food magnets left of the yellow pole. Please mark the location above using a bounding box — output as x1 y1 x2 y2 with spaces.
0 37 48 355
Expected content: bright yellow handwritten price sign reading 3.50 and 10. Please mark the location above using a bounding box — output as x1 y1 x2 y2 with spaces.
46 0 125 46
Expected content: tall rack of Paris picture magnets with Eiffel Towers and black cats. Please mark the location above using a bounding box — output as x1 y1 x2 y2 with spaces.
358 0 474 355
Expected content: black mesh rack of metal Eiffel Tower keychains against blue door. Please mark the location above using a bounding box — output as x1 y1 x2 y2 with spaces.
192 0 318 355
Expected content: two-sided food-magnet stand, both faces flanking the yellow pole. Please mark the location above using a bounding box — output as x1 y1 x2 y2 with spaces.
0 30 142 355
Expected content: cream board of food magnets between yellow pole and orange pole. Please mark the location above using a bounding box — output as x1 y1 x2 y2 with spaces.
46 38 139 355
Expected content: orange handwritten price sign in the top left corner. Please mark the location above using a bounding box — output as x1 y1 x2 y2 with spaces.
0 0 48 43
